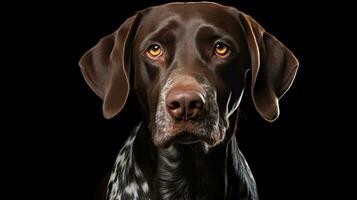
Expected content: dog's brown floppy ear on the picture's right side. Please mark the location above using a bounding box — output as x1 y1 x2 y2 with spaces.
239 13 299 122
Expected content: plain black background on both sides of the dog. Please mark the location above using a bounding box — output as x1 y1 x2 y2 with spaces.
1 0 354 200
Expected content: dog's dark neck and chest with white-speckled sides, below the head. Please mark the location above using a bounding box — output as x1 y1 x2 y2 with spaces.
107 114 258 200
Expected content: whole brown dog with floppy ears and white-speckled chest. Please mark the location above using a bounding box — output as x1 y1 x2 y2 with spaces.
79 2 299 200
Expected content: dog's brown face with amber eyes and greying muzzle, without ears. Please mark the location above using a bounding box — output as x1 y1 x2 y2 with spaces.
132 4 249 147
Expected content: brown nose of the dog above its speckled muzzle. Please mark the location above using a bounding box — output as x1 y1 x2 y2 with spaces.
166 89 204 121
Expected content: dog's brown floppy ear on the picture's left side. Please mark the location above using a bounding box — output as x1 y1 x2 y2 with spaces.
79 16 139 119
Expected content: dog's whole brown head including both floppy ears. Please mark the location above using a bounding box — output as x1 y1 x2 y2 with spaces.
80 3 298 148
